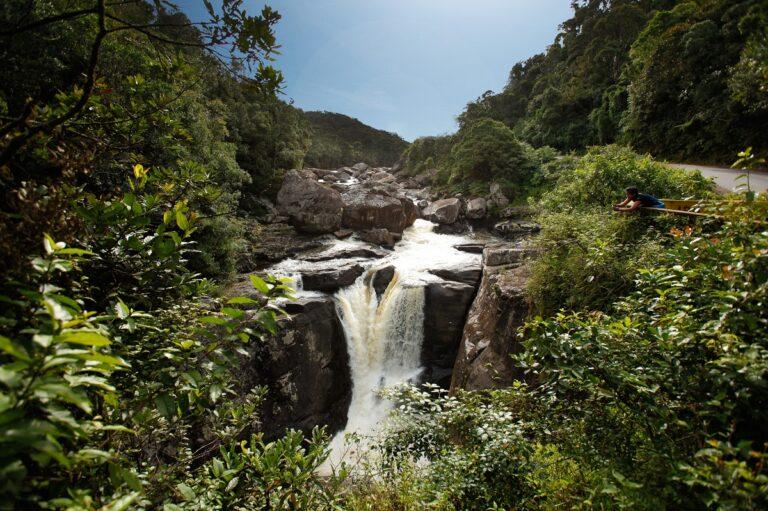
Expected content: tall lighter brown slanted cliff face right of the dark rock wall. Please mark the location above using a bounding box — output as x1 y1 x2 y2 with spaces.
451 248 528 392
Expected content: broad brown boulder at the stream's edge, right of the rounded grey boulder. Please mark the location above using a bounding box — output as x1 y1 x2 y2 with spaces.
341 181 418 234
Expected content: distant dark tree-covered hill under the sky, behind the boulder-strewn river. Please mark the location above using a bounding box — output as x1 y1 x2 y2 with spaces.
304 112 408 168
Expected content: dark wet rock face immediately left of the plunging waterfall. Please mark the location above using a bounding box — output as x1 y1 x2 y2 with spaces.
249 297 352 439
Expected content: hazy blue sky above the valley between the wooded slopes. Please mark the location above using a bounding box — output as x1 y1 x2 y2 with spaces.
180 0 571 140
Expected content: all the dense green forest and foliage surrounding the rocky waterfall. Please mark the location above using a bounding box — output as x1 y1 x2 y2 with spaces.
0 0 768 511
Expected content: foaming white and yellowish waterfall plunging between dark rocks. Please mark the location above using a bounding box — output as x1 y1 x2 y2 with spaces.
321 220 479 473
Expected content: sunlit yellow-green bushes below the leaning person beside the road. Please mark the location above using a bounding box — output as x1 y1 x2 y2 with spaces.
526 146 712 315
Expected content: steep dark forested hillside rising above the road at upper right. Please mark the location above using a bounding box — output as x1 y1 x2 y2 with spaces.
459 0 768 163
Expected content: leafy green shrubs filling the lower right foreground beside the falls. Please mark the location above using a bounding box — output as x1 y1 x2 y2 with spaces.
351 197 768 510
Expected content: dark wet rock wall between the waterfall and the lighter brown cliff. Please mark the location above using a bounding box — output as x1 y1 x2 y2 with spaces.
421 281 476 388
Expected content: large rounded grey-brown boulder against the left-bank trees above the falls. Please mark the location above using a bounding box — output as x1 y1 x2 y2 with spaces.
277 170 344 234
